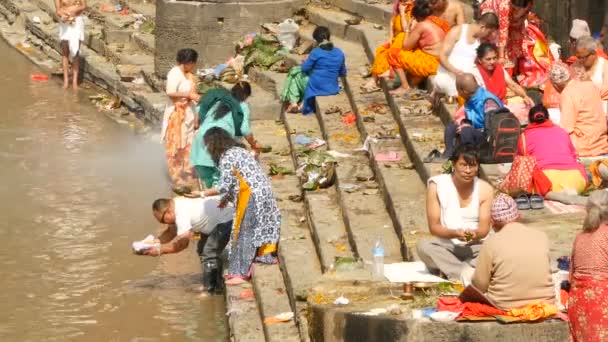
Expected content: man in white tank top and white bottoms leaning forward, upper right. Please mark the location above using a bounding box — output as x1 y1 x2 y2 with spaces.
433 12 498 96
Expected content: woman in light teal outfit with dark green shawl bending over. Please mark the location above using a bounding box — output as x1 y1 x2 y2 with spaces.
190 81 261 189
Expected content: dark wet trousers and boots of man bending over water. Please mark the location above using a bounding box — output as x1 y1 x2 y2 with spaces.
196 221 232 292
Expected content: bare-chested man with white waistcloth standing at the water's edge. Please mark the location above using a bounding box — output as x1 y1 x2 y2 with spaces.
55 0 87 89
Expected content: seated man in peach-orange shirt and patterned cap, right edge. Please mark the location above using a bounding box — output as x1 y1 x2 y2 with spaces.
550 64 608 157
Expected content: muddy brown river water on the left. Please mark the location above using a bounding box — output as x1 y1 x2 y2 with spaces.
0 41 227 342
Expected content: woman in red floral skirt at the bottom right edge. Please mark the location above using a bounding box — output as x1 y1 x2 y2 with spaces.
568 190 608 342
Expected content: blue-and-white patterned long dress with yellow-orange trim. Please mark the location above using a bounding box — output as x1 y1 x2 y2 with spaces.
218 147 281 279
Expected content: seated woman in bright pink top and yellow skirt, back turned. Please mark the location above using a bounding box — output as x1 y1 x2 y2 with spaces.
517 104 587 209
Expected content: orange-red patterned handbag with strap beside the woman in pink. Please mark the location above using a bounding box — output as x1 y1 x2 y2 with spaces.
498 133 536 197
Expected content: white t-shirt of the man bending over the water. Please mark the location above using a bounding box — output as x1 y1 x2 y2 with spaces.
173 196 235 235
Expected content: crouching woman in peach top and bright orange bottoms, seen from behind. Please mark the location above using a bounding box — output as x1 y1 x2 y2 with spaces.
389 0 449 95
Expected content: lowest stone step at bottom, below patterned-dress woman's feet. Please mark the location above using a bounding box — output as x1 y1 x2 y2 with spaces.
226 283 265 342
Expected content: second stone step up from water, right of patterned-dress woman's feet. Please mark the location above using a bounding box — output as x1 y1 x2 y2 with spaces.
252 264 300 342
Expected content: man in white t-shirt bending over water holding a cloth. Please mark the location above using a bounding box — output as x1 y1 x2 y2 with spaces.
134 196 235 293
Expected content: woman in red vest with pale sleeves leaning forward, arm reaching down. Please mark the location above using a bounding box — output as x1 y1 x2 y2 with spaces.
471 43 534 123
